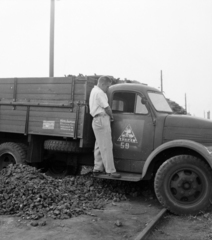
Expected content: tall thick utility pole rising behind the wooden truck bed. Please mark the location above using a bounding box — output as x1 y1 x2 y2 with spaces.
49 0 55 77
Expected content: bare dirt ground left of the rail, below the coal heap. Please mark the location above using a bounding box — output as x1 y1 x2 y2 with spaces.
0 197 161 240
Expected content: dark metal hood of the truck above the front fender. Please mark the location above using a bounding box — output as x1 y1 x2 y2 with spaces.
163 115 212 146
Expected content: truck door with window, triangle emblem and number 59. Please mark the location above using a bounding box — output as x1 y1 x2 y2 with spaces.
111 91 154 173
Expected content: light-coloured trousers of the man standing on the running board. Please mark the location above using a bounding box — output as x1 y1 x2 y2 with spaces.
92 115 116 173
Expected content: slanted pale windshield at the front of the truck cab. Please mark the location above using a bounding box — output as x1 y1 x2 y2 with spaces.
148 92 172 112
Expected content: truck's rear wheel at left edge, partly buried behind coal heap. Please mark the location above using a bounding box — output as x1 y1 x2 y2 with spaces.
0 142 26 170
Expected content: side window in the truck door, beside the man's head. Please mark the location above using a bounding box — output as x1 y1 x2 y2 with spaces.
112 92 148 114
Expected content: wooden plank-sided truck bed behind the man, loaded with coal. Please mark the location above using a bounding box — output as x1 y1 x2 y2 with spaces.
0 76 96 147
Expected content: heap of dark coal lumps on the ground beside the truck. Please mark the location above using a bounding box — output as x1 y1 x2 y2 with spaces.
0 164 154 220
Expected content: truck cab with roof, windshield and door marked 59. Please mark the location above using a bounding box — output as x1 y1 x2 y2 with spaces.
109 84 172 173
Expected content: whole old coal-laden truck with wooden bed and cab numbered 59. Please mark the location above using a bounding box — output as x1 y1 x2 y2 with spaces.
0 76 212 214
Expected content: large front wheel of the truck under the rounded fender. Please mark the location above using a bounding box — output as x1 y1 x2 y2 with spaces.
154 155 212 215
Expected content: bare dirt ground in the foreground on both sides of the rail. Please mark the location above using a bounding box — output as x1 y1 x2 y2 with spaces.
0 197 212 240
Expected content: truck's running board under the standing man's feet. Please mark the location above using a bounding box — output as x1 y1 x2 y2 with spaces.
94 172 142 182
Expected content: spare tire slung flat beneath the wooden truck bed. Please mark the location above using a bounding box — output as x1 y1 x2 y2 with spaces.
44 140 82 152
